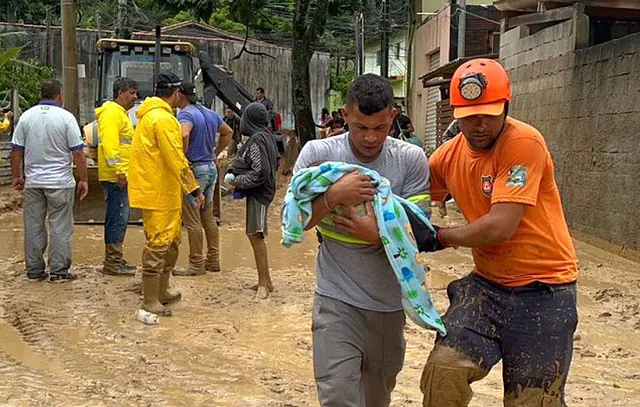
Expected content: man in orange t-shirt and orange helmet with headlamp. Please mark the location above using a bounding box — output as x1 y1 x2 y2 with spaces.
421 59 578 407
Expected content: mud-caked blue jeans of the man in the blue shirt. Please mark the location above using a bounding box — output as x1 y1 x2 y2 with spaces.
182 163 220 270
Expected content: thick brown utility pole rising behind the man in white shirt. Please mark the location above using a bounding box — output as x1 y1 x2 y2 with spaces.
60 0 80 119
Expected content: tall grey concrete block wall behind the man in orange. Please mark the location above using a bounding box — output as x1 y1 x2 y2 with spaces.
500 15 640 251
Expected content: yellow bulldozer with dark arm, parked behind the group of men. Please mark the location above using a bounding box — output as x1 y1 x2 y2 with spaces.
74 38 260 224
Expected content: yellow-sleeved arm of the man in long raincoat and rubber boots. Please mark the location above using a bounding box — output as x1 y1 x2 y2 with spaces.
154 119 200 196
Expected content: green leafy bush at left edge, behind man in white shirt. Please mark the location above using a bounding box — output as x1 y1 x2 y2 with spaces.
0 59 55 110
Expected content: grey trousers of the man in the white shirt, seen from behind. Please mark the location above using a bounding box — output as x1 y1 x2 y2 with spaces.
24 188 75 278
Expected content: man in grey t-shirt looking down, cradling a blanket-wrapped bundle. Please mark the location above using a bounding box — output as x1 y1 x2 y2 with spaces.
294 74 429 407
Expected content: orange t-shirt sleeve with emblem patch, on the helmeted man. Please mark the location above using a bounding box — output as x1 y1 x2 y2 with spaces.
491 137 549 206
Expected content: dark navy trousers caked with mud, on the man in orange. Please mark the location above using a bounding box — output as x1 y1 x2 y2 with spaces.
421 274 578 407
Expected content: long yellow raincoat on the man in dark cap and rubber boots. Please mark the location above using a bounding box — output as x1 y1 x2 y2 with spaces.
129 97 198 211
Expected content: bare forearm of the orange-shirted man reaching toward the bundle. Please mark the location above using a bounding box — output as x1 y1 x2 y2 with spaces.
438 203 526 247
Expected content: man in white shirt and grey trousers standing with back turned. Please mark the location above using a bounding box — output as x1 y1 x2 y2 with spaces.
11 80 89 282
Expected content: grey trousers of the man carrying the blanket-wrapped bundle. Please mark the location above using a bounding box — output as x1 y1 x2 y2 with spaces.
312 294 405 407
